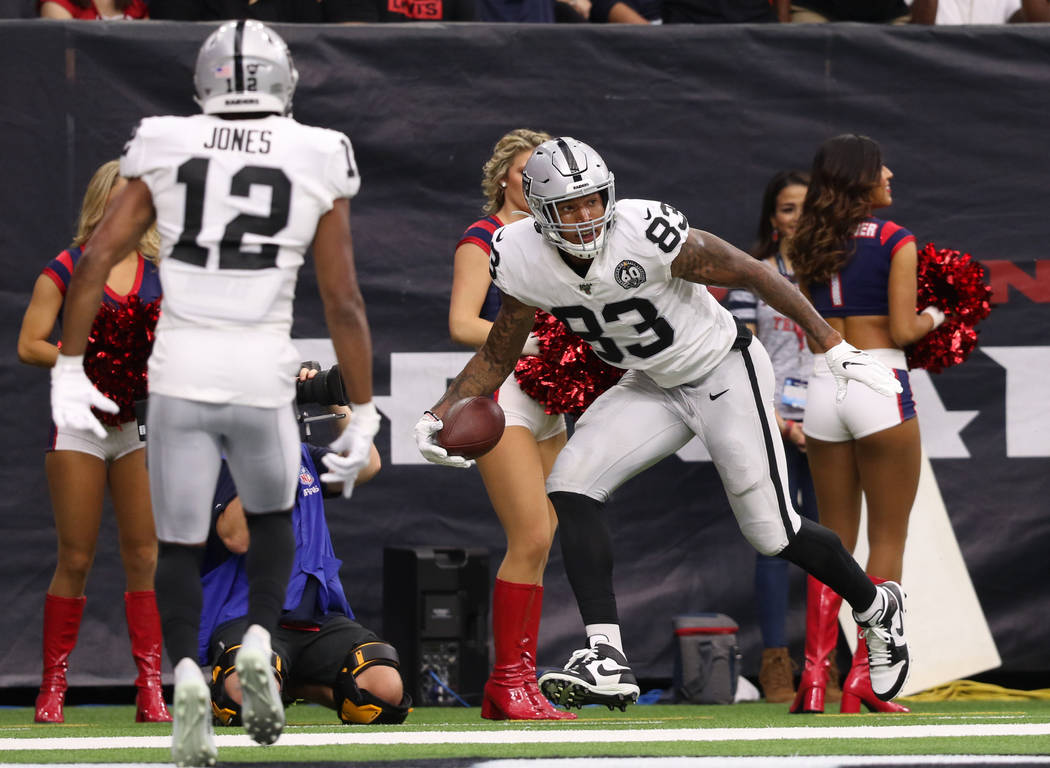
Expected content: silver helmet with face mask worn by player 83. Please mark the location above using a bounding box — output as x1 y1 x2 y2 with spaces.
522 137 616 258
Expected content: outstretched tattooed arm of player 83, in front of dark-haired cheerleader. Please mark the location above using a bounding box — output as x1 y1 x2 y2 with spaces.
671 229 842 351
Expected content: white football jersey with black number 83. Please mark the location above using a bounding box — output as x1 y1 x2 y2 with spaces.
489 200 736 388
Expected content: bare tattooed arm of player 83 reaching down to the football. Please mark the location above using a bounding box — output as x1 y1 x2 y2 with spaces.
431 293 536 418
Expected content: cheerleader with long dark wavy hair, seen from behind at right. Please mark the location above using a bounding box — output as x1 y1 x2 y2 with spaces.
791 134 945 713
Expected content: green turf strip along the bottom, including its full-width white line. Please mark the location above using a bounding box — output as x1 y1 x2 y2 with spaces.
0 701 1050 764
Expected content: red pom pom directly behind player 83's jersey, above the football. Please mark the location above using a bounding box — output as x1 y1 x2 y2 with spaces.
515 312 624 416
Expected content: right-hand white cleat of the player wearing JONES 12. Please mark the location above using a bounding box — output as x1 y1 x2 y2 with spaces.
235 624 285 744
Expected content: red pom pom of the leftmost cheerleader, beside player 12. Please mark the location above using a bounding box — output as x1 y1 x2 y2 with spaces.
84 296 161 427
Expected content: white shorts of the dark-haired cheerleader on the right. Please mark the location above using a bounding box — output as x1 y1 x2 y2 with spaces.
802 349 916 442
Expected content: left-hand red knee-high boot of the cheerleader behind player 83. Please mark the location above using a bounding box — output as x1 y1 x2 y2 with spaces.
481 579 571 720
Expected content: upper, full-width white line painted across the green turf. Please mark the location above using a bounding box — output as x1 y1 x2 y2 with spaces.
0 723 1050 752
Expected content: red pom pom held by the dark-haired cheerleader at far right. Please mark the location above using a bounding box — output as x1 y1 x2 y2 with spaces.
906 243 991 373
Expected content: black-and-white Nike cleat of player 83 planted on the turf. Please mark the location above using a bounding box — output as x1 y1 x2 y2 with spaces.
540 643 638 711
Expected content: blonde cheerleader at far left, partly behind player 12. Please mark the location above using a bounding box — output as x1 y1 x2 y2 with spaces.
18 160 171 723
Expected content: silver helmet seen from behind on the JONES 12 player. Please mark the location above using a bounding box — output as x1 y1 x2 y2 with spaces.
193 19 299 115
